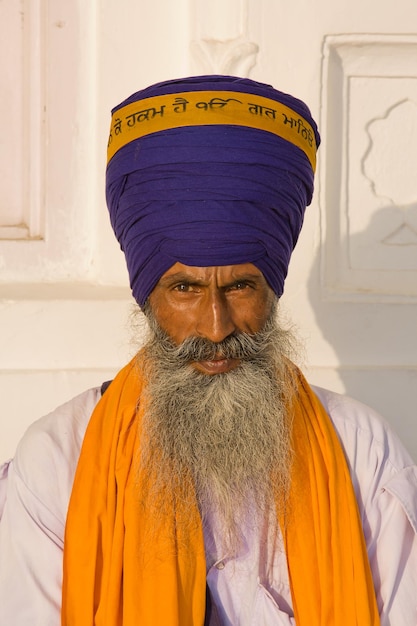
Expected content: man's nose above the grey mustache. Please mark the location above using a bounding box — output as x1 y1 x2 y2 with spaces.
196 291 236 343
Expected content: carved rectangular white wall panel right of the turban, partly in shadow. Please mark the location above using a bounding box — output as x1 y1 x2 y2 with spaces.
319 35 417 302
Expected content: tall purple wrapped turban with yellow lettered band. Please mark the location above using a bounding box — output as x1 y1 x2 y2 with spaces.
106 76 320 305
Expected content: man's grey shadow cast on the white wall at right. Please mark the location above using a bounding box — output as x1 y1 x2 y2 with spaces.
308 205 417 458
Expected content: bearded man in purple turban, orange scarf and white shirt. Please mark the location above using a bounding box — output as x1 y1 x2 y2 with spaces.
0 76 417 626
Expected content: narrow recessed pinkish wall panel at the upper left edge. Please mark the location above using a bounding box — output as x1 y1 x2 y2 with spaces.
0 0 45 240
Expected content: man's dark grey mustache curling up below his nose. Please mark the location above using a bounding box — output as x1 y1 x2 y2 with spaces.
146 322 273 366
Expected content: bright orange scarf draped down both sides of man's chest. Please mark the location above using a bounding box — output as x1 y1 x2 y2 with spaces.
62 360 379 626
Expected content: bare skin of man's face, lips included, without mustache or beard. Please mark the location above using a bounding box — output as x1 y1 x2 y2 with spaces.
149 263 275 375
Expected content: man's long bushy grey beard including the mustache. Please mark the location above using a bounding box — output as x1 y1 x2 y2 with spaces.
135 302 293 550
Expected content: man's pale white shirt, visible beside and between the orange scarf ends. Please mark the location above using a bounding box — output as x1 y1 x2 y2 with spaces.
0 388 417 626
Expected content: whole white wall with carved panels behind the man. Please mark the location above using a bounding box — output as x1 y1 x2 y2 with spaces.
0 0 417 459
